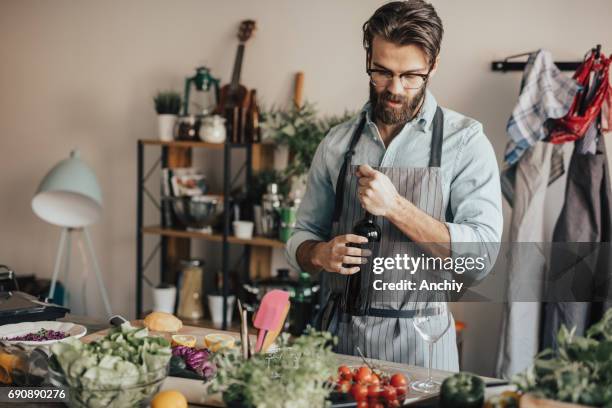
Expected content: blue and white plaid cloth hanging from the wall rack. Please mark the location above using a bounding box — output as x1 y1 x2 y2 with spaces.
504 50 580 166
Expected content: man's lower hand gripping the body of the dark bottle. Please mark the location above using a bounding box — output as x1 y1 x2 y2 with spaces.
311 234 371 275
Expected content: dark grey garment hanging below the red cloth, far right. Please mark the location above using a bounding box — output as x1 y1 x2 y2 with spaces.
542 126 612 348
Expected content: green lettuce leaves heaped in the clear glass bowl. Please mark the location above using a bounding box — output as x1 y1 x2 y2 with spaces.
51 323 172 408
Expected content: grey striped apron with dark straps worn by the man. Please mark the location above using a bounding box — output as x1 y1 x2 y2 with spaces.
321 107 459 371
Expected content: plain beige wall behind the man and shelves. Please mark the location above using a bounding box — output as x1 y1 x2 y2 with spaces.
0 0 612 373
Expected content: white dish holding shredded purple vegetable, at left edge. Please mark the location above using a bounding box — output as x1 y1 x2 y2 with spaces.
0 321 87 346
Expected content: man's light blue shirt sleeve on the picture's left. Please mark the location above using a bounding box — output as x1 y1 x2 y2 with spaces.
286 135 335 270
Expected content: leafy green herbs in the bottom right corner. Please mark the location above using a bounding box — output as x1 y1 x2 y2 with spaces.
513 309 612 407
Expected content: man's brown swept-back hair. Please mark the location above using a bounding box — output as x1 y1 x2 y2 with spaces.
363 0 444 67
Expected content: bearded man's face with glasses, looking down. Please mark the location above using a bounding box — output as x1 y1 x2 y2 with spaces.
370 36 437 125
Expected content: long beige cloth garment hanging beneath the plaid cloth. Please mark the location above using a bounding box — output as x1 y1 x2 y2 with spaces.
496 142 555 378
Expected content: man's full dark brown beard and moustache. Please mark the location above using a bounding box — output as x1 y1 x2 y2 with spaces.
370 84 426 125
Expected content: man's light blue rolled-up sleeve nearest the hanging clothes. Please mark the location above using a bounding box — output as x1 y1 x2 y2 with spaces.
446 124 503 279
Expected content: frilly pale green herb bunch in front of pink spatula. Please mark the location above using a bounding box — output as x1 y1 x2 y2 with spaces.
211 330 336 408
